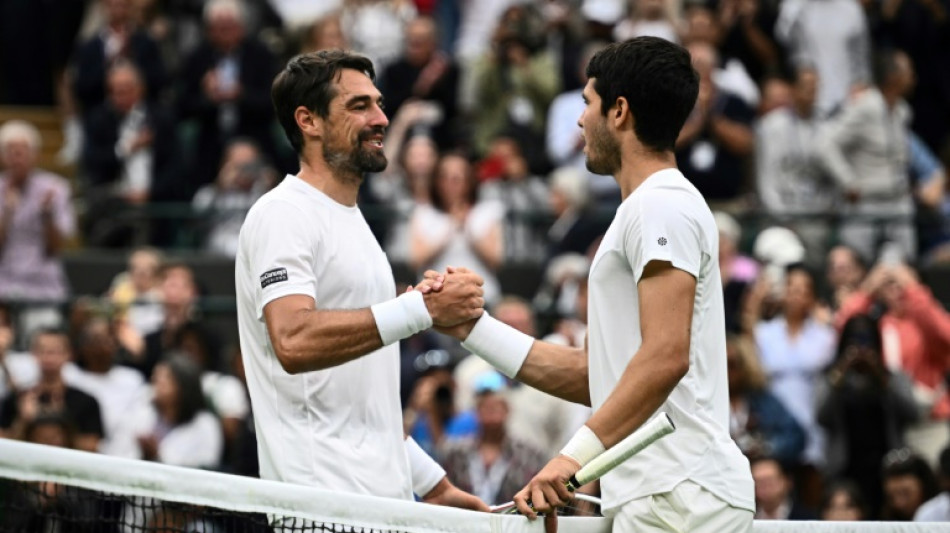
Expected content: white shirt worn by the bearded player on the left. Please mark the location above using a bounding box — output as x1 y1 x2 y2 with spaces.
235 175 412 499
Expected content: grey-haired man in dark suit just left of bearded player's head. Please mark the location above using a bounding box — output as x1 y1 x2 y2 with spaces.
178 0 280 193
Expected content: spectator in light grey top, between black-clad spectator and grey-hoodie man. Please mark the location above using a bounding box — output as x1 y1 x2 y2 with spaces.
755 68 835 265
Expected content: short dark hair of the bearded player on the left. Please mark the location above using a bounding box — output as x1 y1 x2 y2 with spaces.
271 50 376 154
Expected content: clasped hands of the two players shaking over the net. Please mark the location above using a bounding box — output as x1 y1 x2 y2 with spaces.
407 267 485 340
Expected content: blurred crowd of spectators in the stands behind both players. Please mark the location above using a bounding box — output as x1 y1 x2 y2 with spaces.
0 0 950 520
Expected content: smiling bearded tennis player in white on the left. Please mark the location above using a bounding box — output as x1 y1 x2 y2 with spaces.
235 51 487 510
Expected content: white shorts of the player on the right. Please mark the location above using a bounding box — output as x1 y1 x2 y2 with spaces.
613 480 753 533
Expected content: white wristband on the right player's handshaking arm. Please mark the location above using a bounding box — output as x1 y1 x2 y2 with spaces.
462 312 534 379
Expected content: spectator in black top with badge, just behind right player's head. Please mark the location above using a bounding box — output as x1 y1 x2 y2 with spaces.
676 42 755 203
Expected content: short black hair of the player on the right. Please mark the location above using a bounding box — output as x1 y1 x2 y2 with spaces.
586 37 699 152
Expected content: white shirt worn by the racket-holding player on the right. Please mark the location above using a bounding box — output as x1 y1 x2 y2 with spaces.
588 169 755 514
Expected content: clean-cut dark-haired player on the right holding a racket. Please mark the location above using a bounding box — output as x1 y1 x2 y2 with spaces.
427 37 755 533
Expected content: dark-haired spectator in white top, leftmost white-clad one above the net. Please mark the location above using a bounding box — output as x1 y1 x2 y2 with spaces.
63 317 148 459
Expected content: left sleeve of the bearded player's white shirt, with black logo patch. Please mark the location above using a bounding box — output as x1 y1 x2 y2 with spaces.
248 201 320 318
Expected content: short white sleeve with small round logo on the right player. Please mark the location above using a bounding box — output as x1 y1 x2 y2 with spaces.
624 190 703 283
